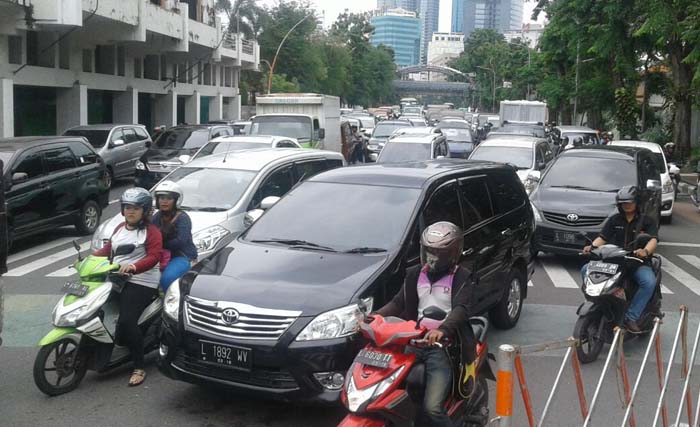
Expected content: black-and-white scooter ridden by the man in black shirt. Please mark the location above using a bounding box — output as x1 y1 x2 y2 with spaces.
574 234 663 363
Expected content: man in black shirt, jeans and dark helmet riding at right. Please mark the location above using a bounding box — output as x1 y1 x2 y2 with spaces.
581 185 658 333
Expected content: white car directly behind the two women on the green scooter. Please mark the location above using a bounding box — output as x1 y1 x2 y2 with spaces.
92 148 344 259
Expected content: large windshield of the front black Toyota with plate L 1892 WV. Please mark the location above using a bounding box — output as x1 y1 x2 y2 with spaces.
245 182 421 251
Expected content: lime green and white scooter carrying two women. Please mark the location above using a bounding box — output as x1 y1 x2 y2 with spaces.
34 242 163 396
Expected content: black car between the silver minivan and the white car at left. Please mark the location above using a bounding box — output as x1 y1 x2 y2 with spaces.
135 125 234 189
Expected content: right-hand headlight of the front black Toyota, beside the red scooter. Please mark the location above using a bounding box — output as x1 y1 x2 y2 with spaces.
296 298 373 341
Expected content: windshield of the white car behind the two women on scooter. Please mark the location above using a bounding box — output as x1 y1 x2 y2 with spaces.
168 167 256 212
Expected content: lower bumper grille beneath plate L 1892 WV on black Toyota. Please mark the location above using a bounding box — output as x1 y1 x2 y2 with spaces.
173 350 299 390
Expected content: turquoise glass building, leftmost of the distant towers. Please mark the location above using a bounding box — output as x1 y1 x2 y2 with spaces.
370 9 421 67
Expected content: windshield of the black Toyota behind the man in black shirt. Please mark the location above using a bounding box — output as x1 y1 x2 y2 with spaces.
540 156 637 192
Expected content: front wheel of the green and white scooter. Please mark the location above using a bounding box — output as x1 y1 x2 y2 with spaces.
34 338 87 396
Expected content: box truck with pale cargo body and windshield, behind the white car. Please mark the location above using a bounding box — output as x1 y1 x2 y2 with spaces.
250 93 342 153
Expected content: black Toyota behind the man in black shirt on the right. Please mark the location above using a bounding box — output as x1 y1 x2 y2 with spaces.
530 146 661 255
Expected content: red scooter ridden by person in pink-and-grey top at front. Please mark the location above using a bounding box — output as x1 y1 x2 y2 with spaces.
338 307 494 427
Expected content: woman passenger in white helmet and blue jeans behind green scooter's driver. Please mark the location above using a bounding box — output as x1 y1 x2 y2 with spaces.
152 181 197 290
